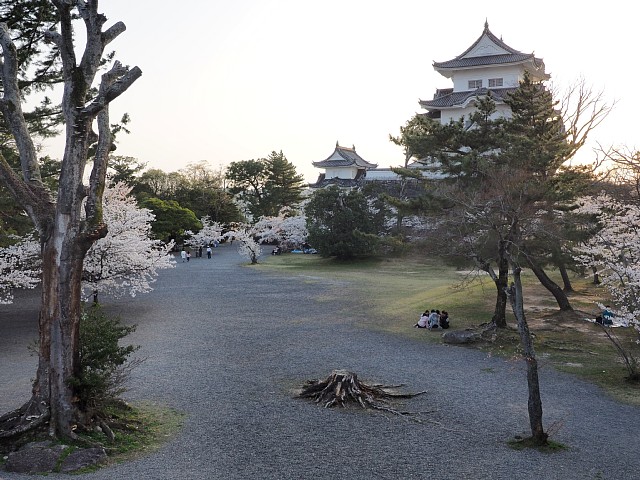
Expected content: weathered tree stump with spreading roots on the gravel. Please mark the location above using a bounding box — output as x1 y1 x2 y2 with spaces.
298 370 427 416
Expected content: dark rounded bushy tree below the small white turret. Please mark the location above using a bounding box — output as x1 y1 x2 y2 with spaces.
305 186 384 260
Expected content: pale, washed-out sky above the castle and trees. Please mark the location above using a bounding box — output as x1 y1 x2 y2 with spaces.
46 0 640 182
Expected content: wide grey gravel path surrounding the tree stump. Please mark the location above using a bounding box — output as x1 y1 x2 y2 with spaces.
0 245 640 480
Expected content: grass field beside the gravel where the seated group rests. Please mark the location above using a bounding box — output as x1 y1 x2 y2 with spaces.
258 254 640 405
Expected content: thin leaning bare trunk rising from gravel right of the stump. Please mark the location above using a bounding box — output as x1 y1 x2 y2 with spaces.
508 267 547 445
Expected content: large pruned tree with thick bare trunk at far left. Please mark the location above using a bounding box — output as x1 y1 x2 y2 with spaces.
0 0 142 439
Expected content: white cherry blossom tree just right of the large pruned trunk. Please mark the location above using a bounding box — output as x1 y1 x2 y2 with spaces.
82 183 175 303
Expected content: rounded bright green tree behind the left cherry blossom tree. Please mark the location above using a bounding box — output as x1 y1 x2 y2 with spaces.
140 198 202 244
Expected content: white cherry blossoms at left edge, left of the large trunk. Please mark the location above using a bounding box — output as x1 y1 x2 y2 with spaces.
0 236 41 304
